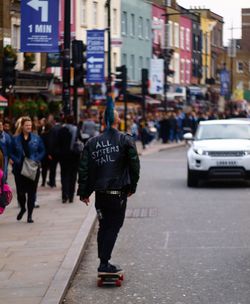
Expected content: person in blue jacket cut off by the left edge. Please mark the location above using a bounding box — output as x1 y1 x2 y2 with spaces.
0 119 12 181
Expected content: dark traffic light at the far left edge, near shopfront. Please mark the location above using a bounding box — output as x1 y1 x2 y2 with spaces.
2 55 16 88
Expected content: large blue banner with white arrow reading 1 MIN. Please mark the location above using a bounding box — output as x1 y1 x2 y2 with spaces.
21 0 59 53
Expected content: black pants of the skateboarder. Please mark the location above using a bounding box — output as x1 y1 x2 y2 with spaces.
95 192 127 263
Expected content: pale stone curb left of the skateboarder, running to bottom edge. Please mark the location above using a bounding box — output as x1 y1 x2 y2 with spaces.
40 202 96 304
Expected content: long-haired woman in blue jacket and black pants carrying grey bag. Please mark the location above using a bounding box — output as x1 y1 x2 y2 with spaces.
11 117 45 223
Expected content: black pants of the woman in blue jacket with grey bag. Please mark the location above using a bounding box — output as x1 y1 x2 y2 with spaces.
15 170 39 217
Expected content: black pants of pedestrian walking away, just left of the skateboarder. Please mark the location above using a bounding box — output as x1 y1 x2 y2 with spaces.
60 157 79 200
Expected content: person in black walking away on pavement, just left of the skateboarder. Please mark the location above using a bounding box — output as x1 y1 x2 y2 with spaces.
58 116 80 203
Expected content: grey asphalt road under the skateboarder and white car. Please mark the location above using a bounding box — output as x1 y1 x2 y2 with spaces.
65 148 250 304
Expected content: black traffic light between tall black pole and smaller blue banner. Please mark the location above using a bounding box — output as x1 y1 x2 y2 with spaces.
72 40 86 87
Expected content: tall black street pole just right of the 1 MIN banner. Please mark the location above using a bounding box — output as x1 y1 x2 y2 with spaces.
62 0 71 116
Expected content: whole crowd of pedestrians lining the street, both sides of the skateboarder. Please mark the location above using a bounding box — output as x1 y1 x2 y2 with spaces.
0 105 248 223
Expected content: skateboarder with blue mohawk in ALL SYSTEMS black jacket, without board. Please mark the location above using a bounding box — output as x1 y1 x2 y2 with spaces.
77 97 140 273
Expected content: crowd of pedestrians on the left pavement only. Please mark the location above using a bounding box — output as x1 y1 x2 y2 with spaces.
0 115 99 223
